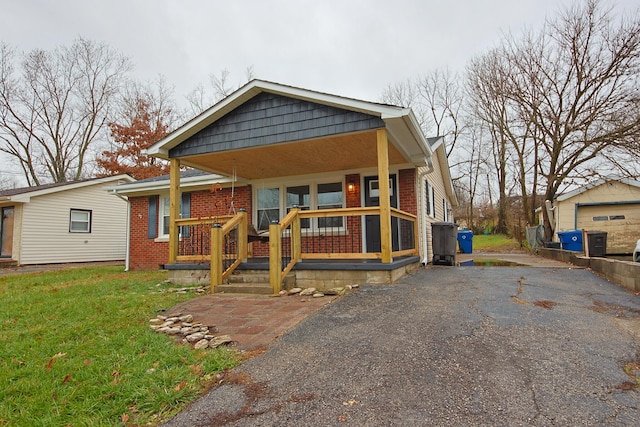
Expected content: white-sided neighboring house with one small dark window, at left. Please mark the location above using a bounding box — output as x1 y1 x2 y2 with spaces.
0 175 134 265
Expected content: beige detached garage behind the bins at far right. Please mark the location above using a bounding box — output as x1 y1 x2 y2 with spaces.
540 178 640 254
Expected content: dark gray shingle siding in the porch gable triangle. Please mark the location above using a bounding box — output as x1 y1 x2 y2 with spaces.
169 92 384 158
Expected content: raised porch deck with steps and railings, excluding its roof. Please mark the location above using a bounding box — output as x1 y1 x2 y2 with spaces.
165 204 420 294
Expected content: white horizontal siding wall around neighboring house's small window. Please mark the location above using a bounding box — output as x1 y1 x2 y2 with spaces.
19 183 127 264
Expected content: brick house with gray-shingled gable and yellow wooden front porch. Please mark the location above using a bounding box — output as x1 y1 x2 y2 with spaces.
111 80 457 291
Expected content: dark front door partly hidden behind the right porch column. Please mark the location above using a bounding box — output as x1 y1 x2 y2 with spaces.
364 174 399 252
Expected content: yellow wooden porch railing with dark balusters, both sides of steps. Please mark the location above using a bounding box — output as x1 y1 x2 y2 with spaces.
175 207 418 294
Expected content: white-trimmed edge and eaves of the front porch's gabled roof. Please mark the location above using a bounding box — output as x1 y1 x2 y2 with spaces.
146 80 432 168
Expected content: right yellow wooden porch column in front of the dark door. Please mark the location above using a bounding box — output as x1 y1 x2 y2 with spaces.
376 129 392 264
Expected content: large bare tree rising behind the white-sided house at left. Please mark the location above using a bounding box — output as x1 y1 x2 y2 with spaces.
0 38 130 185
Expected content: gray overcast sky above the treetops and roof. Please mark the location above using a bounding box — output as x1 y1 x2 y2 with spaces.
0 0 637 102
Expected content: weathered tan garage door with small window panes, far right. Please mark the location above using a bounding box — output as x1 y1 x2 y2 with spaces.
577 203 640 254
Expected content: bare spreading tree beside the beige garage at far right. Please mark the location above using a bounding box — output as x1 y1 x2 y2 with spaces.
507 0 640 239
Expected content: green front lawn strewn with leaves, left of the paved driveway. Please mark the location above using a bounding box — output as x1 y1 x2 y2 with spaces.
0 267 239 426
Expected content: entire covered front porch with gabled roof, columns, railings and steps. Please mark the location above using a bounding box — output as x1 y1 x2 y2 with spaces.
148 81 431 294
